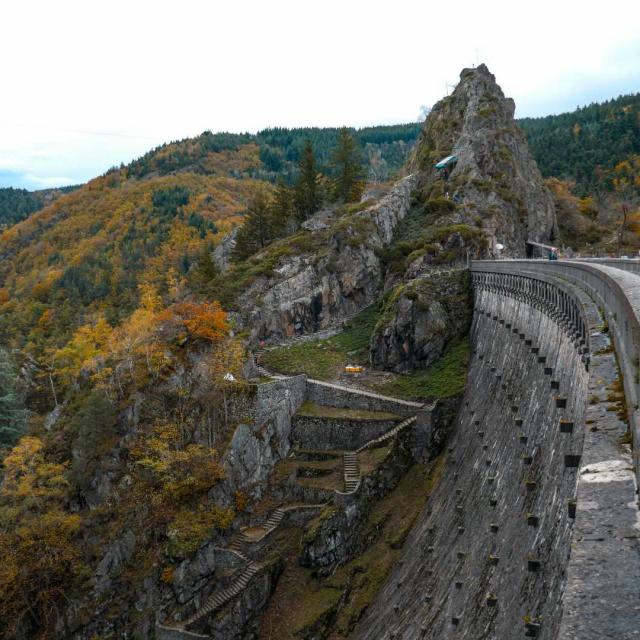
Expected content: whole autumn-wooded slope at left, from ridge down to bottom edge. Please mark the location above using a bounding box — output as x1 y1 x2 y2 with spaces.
0 140 271 638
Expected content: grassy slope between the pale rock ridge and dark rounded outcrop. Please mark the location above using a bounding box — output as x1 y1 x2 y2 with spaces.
262 305 380 380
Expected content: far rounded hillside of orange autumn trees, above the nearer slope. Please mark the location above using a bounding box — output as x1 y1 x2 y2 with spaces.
0 172 257 370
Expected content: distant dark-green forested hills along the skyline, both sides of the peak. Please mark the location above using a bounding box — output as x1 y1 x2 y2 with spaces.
0 94 640 229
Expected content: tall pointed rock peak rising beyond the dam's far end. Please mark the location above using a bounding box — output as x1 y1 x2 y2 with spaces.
412 64 557 257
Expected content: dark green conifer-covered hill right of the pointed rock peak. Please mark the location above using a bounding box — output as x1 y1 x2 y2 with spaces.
519 93 640 196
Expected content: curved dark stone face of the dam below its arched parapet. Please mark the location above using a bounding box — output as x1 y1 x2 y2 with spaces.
355 272 588 640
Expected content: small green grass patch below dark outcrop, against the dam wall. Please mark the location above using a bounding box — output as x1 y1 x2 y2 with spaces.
377 339 469 400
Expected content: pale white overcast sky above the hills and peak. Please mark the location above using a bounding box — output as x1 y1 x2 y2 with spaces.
0 0 640 189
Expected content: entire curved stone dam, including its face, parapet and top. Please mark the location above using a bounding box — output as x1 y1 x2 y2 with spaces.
353 261 640 640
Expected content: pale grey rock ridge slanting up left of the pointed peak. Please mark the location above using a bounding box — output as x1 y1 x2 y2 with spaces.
238 176 416 339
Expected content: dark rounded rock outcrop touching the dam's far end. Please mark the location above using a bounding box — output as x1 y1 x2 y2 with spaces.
371 270 472 373
